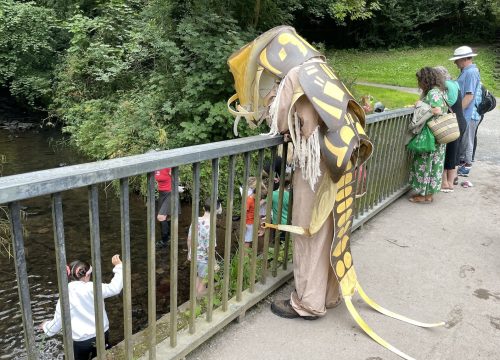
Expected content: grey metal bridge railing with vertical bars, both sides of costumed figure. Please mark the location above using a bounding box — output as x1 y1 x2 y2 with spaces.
0 109 412 360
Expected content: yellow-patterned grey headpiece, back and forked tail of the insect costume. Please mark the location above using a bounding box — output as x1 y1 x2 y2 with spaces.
228 26 444 359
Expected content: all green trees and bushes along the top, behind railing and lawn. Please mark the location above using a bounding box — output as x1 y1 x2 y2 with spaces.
0 0 500 197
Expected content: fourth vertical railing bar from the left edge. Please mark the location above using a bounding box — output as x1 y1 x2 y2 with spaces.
120 178 134 360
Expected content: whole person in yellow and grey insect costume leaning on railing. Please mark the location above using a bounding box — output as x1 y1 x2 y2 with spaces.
228 26 444 359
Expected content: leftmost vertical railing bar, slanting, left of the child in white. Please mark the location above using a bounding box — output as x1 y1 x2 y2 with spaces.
9 201 38 360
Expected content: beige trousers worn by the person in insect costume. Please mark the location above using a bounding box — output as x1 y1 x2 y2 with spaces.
291 165 340 316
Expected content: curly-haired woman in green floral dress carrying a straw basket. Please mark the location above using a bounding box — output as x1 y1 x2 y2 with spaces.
409 67 448 203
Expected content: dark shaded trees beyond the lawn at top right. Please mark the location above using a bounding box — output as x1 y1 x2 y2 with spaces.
318 0 500 48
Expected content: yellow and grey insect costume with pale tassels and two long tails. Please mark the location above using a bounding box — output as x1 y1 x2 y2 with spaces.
228 26 444 359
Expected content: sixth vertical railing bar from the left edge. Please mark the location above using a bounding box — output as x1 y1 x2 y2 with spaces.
170 167 179 347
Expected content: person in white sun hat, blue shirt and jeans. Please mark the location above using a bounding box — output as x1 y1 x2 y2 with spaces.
450 46 481 176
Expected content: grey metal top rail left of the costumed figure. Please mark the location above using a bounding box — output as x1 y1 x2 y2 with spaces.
0 135 283 204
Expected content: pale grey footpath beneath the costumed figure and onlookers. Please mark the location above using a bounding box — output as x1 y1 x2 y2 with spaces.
187 110 500 360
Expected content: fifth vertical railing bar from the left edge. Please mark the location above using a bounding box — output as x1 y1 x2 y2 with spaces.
147 172 156 360
